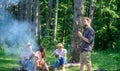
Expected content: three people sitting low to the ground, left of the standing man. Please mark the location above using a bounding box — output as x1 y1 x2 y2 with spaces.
21 43 67 71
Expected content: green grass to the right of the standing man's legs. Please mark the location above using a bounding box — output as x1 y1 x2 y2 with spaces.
92 51 120 71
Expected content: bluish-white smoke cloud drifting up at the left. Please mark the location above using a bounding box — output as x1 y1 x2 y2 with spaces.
0 0 37 56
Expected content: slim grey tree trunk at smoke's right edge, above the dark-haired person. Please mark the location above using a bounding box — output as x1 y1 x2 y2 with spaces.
34 0 41 44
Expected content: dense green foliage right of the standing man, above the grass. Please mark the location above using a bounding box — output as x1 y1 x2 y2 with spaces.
93 0 120 50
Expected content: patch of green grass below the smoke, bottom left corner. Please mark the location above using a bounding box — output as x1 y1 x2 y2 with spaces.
0 48 18 71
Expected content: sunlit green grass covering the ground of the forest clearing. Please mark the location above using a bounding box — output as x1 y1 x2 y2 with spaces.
0 49 120 71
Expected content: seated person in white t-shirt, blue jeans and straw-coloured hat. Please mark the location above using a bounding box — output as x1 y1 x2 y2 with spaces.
51 43 67 71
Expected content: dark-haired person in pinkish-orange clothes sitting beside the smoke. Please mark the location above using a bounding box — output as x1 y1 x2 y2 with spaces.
33 46 49 71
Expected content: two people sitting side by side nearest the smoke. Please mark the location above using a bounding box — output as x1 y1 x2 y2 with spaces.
20 43 49 71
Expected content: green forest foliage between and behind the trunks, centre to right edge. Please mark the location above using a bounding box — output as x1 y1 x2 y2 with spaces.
41 0 120 50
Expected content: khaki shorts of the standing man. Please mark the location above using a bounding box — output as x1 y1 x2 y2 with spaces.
80 52 91 64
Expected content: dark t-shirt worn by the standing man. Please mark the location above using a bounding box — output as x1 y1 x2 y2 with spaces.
80 27 95 52
